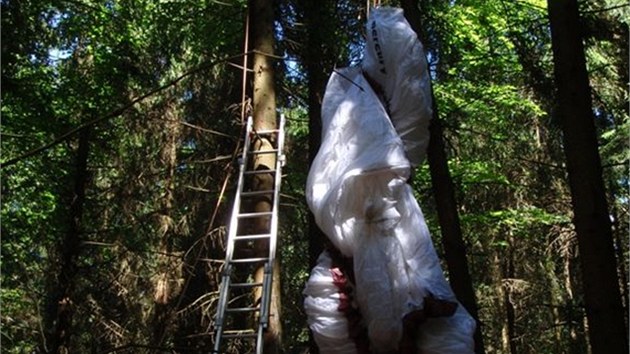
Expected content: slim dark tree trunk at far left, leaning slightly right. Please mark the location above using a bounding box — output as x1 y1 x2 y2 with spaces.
47 128 90 353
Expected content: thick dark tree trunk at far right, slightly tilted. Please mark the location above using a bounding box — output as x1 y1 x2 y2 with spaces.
548 0 628 354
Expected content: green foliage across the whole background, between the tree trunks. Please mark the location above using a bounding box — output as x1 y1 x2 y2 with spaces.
0 0 629 353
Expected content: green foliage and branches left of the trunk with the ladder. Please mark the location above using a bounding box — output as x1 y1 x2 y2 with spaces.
0 1 249 352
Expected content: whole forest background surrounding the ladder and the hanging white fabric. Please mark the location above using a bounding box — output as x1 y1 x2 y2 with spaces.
0 0 630 354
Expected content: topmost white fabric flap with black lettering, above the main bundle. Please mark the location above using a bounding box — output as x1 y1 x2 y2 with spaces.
361 7 433 167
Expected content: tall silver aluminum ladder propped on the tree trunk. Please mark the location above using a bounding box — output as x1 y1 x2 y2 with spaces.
213 114 285 353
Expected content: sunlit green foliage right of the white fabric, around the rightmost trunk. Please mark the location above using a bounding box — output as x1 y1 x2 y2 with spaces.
414 0 627 352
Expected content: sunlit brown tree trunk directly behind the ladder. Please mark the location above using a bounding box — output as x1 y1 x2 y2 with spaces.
249 0 282 353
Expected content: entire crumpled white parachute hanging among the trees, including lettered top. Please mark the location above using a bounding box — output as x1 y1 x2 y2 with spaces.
304 8 475 354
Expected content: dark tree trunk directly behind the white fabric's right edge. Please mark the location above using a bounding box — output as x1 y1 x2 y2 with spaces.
401 0 485 354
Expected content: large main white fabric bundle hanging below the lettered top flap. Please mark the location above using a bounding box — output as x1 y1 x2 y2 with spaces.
306 68 475 354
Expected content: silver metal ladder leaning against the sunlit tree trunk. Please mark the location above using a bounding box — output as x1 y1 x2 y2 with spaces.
212 115 285 354
